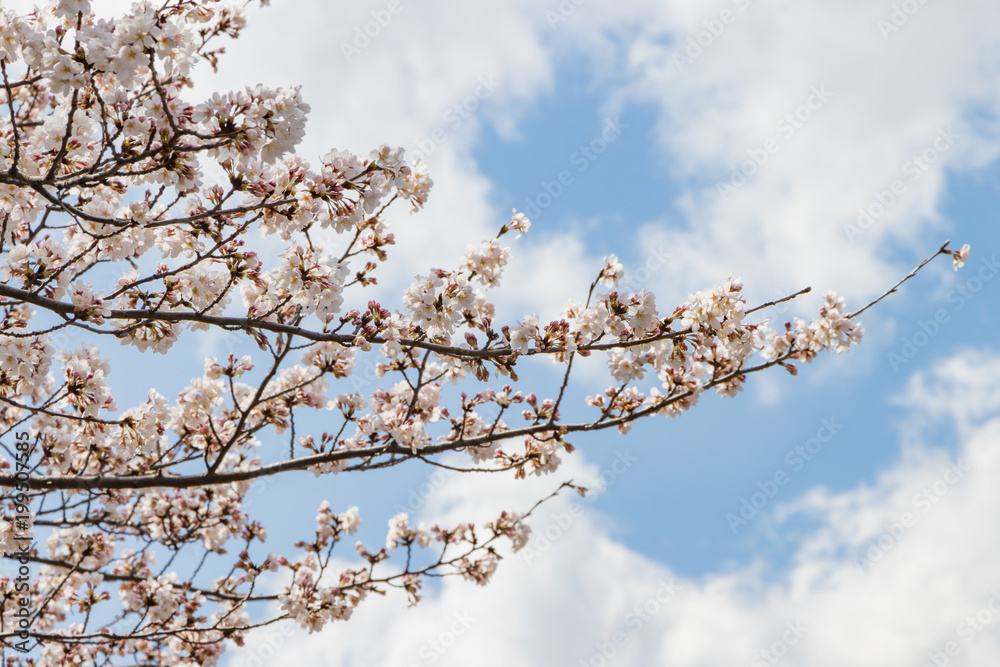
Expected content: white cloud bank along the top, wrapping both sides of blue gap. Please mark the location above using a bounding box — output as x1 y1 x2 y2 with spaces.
74 0 1000 340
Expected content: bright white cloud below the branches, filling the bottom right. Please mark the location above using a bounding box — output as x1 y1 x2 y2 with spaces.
232 350 1000 667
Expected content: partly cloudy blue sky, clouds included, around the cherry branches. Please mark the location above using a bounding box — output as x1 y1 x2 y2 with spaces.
76 0 1000 667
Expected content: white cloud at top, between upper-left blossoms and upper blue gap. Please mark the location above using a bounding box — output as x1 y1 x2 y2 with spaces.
193 0 585 308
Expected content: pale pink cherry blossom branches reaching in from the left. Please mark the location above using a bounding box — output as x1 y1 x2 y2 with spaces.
0 0 969 667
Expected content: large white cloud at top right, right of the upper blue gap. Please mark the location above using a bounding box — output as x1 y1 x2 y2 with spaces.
588 0 1000 299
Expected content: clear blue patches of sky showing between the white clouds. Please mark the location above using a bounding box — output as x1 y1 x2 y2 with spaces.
418 11 1000 576
